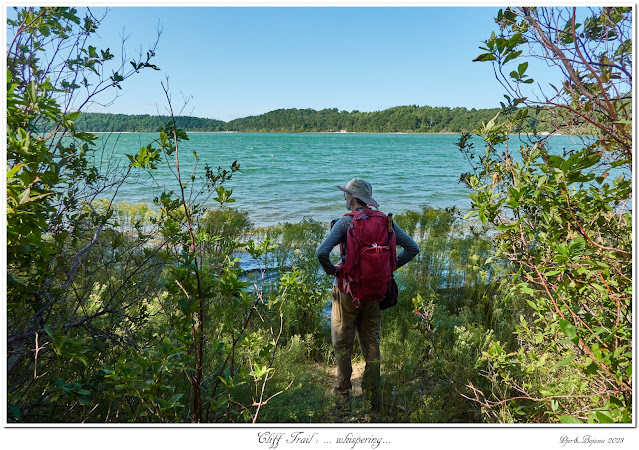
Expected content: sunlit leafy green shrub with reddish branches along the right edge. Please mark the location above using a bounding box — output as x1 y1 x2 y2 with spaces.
459 7 632 422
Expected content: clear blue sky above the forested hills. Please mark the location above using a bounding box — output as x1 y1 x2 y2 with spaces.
7 6 564 120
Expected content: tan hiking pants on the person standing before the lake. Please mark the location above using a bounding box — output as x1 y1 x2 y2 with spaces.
331 286 382 398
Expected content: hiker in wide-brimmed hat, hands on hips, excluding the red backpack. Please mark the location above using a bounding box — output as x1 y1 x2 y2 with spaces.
315 178 419 408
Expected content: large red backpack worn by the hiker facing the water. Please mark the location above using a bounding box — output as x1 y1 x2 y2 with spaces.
338 206 397 307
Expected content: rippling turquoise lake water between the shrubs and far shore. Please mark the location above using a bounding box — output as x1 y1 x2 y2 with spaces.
95 133 596 226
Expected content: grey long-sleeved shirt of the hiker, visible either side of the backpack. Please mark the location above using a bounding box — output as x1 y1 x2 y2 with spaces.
315 212 419 275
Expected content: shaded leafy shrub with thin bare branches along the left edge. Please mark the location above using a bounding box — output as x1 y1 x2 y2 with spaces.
7 7 162 420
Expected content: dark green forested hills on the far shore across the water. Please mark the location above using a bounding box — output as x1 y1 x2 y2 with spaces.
76 105 545 133
